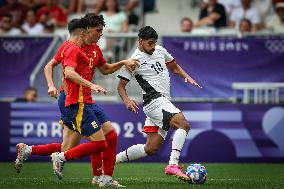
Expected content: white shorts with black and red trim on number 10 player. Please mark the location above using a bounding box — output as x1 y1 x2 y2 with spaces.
143 97 181 139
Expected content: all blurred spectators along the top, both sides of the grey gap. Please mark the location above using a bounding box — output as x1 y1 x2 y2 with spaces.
0 0 284 35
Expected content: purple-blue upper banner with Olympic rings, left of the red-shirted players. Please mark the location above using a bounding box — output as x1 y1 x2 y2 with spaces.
0 37 52 98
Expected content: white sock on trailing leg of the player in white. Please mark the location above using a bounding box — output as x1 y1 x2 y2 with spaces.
115 144 147 163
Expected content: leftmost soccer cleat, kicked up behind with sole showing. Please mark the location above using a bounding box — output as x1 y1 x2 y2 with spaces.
14 143 31 173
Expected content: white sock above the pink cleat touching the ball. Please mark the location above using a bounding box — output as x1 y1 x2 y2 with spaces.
169 129 187 165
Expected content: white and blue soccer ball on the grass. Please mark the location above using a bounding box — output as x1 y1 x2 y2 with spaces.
185 163 207 184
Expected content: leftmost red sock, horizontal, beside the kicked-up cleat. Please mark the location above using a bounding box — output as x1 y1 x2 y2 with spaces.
32 143 61 156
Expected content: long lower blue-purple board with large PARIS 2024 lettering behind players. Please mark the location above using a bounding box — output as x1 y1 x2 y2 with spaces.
0 103 284 162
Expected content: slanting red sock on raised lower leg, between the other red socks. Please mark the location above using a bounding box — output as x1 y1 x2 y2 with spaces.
64 140 107 161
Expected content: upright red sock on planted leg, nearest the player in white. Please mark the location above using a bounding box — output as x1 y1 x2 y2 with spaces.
103 130 117 176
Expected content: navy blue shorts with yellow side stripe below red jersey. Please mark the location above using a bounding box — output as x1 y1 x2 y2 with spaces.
58 92 109 136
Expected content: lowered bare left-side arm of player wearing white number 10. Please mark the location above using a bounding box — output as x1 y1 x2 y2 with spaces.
117 79 139 114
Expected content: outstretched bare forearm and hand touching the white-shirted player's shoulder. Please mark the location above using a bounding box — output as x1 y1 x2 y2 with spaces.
99 59 139 75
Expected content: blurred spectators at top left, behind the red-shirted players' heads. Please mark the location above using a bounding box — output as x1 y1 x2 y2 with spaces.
0 0 154 35
